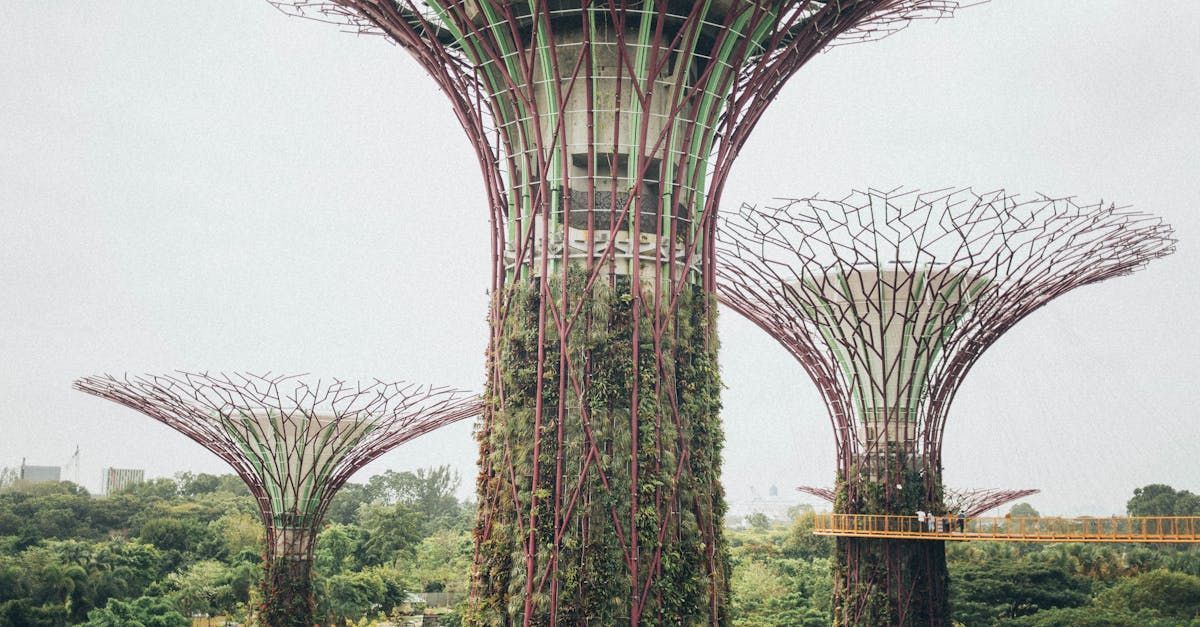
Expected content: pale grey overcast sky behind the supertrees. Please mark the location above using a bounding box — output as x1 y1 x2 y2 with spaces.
0 0 1200 514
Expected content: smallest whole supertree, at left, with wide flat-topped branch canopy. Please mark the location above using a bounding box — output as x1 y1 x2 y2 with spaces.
74 372 481 627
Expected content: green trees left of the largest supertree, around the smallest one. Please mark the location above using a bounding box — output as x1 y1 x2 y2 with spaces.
0 468 474 627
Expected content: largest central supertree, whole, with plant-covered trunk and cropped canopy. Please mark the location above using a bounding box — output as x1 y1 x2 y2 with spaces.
275 0 956 626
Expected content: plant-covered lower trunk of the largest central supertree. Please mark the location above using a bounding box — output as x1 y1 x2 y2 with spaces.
468 273 728 625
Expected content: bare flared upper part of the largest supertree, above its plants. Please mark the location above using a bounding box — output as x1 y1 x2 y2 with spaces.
270 0 959 289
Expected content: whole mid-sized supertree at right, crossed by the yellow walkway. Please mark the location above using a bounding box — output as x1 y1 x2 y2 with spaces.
716 190 1175 625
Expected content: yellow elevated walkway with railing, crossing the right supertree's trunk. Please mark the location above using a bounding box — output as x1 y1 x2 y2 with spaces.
812 514 1200 543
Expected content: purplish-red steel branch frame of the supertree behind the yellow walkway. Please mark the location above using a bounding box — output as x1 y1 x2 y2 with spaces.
718 190 1175 487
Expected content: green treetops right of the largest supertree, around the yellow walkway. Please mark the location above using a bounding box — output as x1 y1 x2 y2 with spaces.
728 485 1200 627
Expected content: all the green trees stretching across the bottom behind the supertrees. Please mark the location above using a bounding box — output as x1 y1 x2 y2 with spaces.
0 468 1200 627
